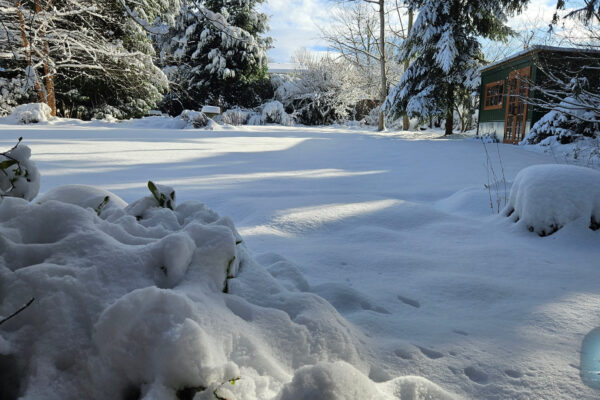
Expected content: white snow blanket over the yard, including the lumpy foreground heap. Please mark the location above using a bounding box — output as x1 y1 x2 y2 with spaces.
0 120 600 400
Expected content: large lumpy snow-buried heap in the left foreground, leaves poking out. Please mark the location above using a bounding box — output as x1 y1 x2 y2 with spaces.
0 185 448 400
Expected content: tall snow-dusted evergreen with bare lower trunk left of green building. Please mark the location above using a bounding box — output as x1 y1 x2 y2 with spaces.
385 0 527 135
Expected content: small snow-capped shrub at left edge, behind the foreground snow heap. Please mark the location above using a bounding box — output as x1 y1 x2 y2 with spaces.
0 138 40 200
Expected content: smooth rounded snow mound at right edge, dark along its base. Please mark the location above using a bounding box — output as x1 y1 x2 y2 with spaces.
502 165 600 236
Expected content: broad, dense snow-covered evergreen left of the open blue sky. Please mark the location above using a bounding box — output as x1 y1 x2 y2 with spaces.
158 0 271 114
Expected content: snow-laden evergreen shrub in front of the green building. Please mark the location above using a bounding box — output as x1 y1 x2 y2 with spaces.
524 97 600 144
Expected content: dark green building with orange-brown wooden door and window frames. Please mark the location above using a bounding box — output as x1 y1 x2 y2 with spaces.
477 46 600 144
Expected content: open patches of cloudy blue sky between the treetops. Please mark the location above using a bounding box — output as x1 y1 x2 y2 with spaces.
260 0 556 63
